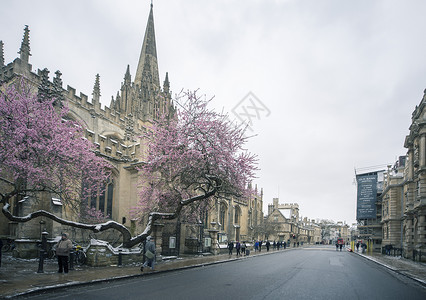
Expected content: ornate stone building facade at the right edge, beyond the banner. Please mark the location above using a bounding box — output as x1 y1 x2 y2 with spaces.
358 90 426 261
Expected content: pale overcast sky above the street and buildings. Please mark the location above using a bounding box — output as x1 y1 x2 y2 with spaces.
0 0 426 224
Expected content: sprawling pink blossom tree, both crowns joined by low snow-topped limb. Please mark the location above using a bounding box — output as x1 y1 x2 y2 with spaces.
0 81 257 248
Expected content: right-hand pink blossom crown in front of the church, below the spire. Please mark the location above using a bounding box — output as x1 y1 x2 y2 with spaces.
129 92 257 247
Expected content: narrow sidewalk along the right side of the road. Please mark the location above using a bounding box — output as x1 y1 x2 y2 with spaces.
353 251 426 286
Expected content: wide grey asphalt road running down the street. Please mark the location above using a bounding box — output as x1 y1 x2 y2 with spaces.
28 246 426 300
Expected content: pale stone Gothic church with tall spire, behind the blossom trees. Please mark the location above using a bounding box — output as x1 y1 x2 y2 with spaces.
0 4 263 253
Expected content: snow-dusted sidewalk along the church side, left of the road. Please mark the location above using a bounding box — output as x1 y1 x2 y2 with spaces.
0 249 266 299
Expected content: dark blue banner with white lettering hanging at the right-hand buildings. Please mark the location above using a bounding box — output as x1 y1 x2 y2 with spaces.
356 173 377 220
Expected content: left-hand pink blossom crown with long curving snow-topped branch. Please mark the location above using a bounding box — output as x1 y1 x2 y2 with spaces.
0 79 120 232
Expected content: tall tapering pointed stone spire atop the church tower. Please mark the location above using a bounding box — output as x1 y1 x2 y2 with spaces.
135 2 160 92
